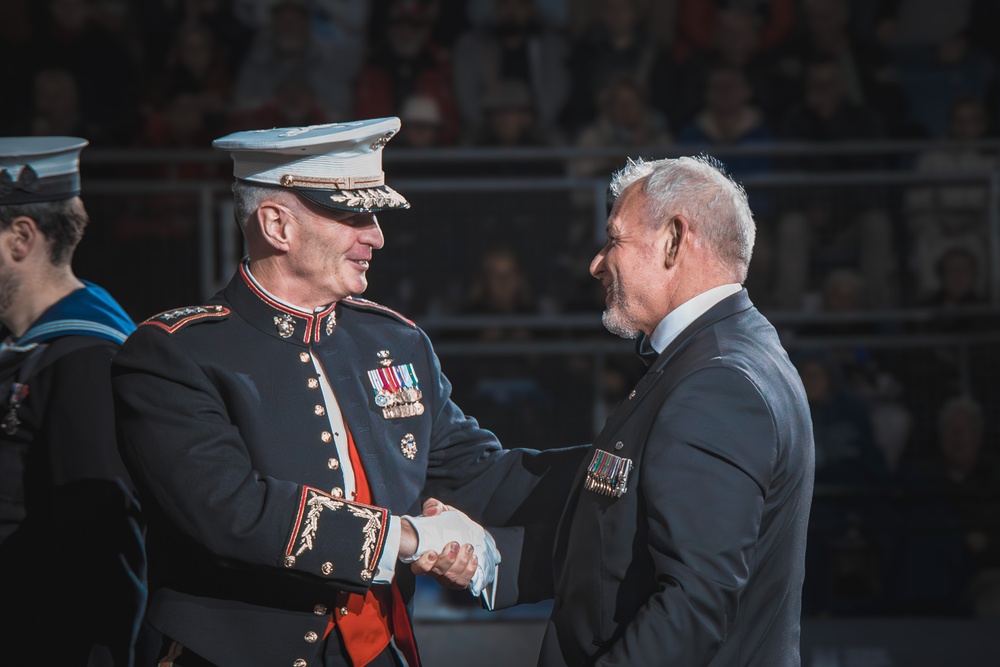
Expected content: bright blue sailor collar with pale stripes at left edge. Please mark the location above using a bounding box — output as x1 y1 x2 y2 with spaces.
0 280 135 356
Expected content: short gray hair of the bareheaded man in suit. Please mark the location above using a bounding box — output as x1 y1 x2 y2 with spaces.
611 155 757 284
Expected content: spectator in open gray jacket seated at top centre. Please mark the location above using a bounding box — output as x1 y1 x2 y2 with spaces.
452 0 570 132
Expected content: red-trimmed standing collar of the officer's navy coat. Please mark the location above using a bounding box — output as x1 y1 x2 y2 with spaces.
225 259 337 345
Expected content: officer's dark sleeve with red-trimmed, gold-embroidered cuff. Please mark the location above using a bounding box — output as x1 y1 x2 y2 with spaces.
112 326 388 590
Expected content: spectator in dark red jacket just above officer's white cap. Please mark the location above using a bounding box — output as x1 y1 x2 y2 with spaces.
354 0 459 144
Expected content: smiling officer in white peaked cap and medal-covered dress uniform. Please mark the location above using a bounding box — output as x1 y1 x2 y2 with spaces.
113 118 579 667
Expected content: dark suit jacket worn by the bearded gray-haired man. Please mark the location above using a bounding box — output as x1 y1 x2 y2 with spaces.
539 290 814 667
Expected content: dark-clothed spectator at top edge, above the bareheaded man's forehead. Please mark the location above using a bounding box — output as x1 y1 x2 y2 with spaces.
566 0 666 135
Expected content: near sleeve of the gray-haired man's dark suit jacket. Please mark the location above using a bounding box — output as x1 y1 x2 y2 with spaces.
595 367 777 667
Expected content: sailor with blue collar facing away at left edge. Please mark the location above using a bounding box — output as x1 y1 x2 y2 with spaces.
0 137 145 667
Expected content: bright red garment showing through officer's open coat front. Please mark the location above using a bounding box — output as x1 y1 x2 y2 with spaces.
326 423 420 667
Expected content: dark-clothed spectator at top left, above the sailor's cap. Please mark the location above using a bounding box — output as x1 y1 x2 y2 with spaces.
34 0 139 146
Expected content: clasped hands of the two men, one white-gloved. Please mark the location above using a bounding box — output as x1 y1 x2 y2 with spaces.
399 498 500 597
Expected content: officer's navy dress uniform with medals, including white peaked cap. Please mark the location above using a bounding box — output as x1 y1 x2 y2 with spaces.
113 119 580 667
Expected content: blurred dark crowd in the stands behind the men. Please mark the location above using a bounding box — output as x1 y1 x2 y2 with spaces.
0 0 1000 628
